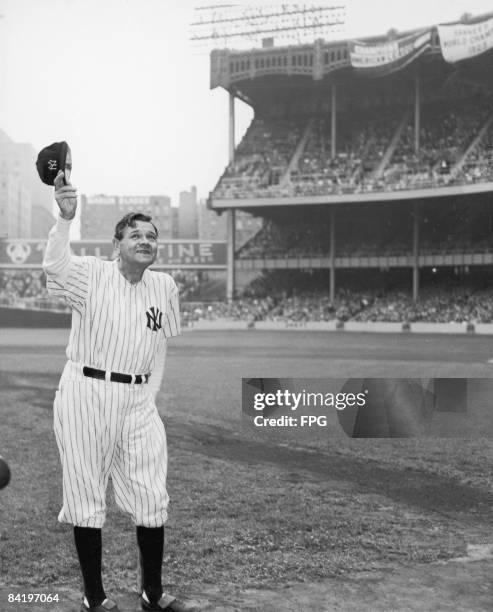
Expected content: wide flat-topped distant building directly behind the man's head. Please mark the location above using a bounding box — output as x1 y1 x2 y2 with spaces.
80 195 172 240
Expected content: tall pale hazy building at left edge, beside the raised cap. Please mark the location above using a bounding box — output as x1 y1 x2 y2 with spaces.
0 130 55 238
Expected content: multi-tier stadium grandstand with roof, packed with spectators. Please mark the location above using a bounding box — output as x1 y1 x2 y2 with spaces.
204 8 493 322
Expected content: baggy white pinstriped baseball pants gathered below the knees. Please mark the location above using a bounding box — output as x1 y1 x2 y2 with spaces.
54 361 169 528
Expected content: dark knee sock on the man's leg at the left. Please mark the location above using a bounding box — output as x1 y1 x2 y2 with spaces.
74 526 106 607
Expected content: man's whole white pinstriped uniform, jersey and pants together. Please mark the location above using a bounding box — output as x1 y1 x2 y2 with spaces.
43 217 180 528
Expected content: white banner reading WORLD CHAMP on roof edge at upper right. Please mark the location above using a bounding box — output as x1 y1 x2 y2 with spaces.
437 17 493 64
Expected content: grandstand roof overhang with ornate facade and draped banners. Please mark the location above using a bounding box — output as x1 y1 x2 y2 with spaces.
210 13 493 108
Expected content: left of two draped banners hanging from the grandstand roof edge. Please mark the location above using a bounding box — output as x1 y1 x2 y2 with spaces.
349 29 431 76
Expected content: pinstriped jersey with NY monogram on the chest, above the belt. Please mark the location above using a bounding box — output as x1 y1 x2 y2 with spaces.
47 256 180 374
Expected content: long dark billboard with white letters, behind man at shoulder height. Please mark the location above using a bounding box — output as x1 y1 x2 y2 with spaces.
0 239 226 268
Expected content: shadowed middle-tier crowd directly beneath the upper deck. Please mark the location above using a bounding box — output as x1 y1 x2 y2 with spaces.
237 201 493 259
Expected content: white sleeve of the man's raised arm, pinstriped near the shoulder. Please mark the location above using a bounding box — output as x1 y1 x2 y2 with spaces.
43 217 90 311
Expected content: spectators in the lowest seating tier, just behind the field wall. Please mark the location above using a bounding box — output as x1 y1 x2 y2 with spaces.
180 270 493 324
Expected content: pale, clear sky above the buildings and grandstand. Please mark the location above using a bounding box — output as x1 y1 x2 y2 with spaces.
0 0 492 204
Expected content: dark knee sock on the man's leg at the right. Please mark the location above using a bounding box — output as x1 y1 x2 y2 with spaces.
137 525 164 603
